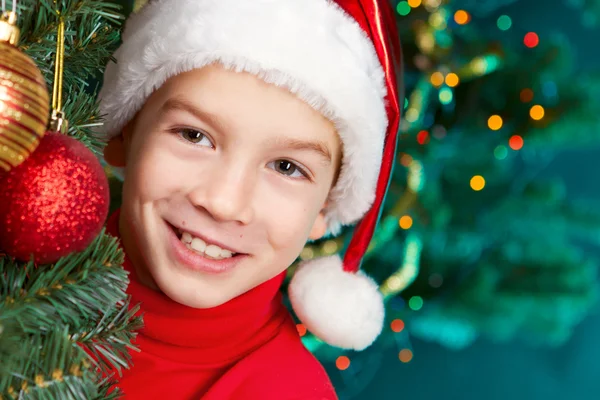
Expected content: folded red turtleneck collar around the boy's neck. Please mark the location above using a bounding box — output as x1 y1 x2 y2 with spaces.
107 211 291 365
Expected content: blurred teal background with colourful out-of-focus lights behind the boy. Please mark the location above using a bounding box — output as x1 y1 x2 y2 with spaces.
126 0 600 400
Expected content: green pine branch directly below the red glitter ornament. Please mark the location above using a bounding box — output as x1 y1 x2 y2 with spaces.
0 230 128 333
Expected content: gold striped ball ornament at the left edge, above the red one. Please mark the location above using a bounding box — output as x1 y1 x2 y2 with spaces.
0 11 50 172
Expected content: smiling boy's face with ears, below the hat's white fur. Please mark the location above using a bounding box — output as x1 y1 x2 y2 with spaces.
106 66 341 308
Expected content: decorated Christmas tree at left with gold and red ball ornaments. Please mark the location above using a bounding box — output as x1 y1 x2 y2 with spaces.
0 0 140 399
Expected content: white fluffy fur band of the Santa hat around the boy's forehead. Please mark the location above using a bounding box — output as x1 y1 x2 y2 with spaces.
99 0 388 234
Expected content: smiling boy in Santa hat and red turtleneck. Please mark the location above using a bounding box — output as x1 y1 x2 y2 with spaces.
100 0 400 400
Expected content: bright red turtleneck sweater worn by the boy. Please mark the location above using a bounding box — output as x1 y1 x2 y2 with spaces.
107 211 337 400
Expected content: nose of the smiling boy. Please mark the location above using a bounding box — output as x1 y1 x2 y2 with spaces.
189 165 255 225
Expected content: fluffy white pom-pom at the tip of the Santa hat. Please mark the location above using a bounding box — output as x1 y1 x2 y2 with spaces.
288 255 385 350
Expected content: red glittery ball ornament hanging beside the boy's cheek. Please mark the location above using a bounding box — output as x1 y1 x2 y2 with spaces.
0 132 109 264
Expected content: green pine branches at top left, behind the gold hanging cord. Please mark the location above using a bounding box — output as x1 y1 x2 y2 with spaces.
9 0 124 155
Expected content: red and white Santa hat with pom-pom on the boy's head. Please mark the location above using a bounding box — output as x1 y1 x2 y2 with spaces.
100 0 401 350
